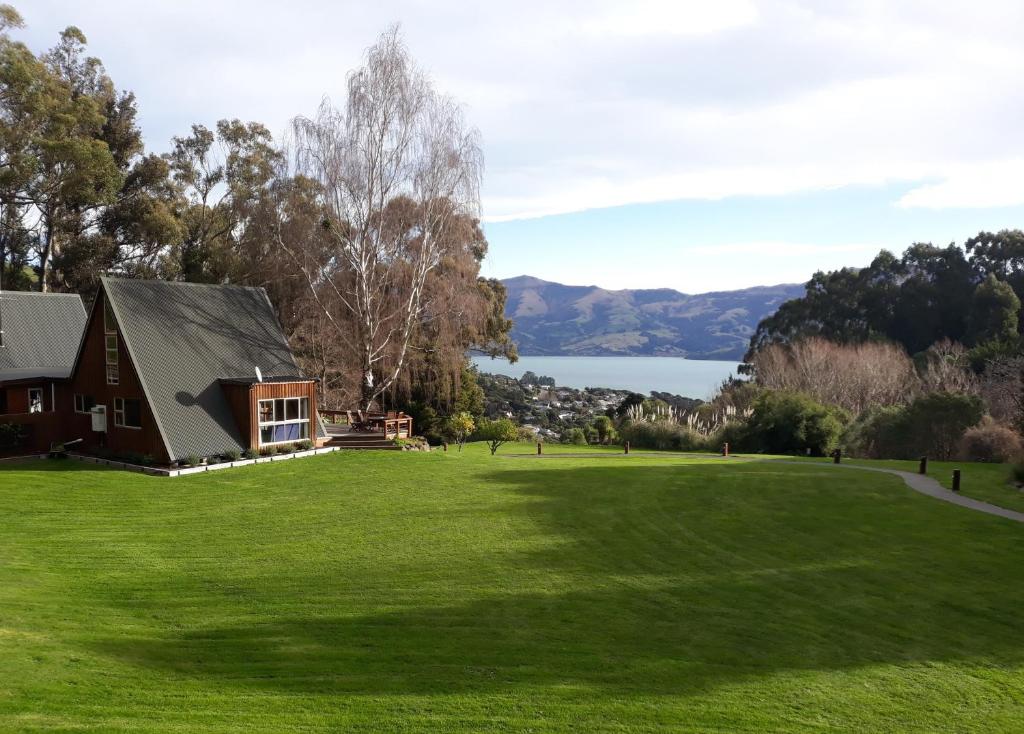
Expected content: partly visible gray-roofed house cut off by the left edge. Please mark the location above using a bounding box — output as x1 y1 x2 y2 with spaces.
0 291 86 446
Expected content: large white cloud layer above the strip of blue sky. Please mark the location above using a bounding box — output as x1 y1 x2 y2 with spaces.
22 0 1024 221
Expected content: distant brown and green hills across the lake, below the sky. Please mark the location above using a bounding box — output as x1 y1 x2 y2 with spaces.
503 275 804 359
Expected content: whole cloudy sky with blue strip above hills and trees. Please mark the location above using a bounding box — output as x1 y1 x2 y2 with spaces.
13 0 1024 293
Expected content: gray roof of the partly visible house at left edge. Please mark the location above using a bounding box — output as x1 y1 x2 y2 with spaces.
0 291 86 380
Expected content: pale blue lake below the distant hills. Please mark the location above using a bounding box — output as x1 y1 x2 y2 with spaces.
472 356 738 399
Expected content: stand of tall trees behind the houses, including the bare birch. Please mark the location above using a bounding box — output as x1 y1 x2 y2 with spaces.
0 5 516 415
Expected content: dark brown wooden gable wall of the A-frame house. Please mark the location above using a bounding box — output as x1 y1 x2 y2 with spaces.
66 291 168 463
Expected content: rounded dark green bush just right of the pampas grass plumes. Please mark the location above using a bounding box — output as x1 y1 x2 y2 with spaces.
744 391 849 457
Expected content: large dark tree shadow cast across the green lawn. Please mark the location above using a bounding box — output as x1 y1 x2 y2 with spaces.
90 464 1024 695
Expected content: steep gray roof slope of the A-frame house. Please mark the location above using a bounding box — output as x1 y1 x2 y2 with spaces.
102 277 302 461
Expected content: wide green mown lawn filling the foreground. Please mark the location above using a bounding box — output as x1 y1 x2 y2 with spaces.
0 446 1024 732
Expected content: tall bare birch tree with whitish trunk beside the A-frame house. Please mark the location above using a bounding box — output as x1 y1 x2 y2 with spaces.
279 27 483 407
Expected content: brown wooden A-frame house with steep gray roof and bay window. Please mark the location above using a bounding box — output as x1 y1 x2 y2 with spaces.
3 277 324 464
